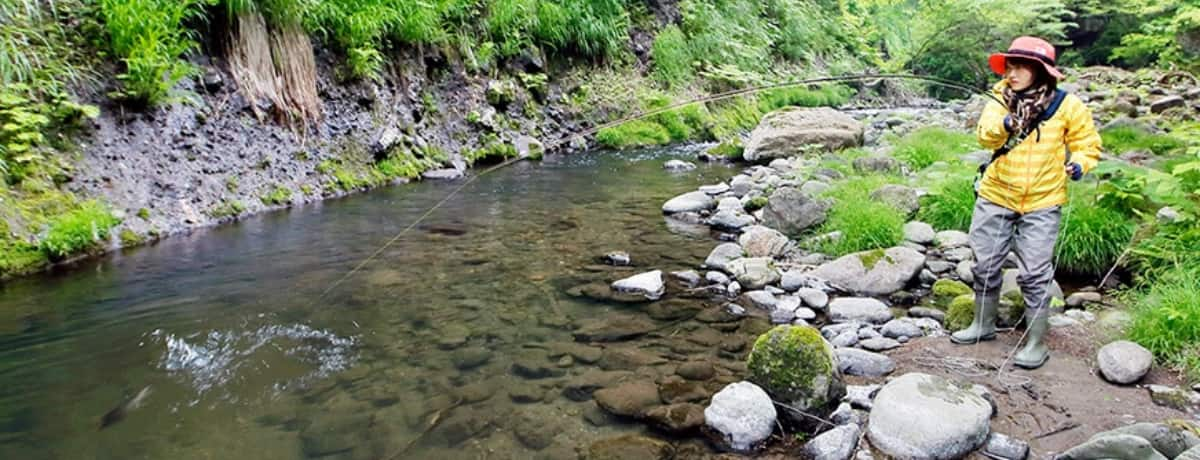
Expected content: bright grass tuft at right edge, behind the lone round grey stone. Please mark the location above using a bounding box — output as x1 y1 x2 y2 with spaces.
1128 265 1200 381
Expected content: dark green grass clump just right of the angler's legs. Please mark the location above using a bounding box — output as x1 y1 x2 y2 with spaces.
1055 189 1136 276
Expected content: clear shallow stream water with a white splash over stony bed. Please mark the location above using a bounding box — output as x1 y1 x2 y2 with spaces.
0 146 733 459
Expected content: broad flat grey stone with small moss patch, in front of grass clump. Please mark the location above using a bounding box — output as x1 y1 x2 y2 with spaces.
811 247 925 295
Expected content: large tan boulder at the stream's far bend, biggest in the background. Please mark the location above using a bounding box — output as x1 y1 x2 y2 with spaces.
742 107 865 163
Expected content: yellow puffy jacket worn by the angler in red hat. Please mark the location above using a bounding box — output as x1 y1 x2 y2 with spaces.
977 80 1100 214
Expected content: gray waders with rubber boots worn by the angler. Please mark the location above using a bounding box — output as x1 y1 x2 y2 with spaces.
950 198 1062 369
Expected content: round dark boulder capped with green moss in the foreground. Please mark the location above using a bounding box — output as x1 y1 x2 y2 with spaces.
746 324 846 423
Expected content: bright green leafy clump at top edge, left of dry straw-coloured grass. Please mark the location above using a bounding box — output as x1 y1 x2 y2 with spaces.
98 0 205 104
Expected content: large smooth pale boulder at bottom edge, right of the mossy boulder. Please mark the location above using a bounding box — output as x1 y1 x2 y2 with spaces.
868 372 992 460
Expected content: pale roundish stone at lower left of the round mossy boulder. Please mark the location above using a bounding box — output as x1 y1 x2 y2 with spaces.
704 382 778 452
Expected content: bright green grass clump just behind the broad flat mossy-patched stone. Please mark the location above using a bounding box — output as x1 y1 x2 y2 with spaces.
817 175 905 256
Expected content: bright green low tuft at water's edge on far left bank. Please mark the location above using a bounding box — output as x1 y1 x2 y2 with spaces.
41 202 120 259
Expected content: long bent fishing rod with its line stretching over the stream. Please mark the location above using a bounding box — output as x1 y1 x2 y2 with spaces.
311 73 1007 303
